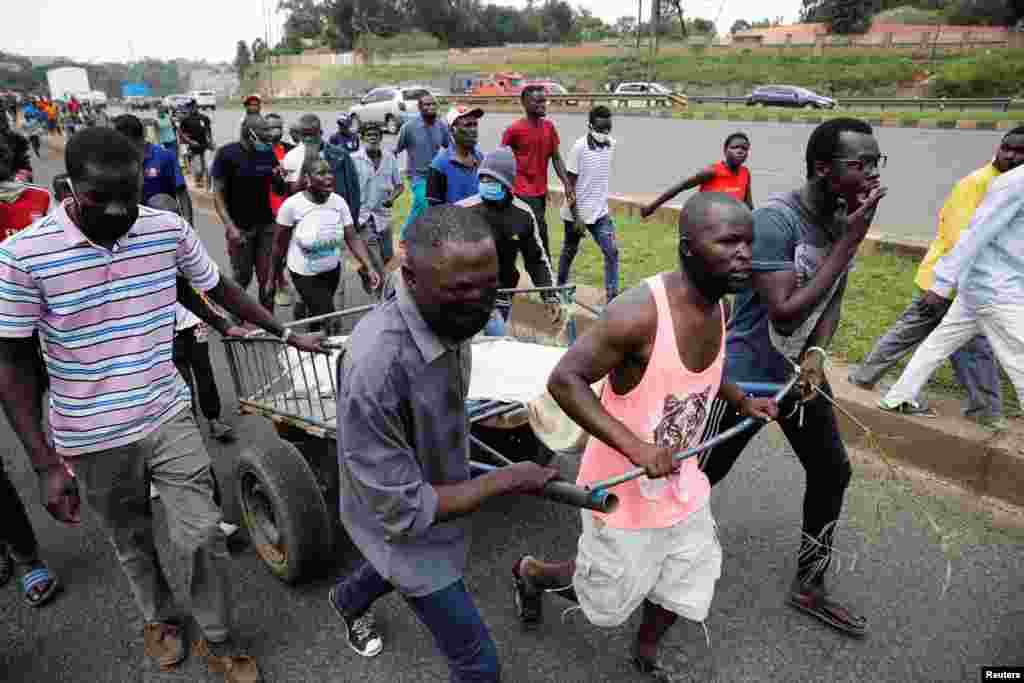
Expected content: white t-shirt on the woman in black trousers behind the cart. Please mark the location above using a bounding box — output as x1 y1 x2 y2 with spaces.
278 193 352 275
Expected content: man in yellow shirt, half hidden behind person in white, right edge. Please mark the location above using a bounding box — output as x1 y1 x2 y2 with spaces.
849 127 1024 429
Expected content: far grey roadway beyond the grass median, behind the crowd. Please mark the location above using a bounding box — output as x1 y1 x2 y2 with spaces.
184 105 1002 240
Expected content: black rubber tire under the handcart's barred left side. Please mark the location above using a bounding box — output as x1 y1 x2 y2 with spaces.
234 440 333 584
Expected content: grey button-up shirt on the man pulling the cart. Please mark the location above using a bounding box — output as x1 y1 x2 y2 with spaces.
338 279 471 597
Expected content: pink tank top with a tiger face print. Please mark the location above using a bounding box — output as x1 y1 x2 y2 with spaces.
577 273 725 528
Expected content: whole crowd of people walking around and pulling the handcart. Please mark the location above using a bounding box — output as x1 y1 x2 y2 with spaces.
0 87 1024 682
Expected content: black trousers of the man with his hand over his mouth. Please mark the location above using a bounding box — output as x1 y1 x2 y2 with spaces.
702 384 852 583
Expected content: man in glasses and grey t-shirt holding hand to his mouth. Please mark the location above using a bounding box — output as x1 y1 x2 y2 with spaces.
702 118 887 637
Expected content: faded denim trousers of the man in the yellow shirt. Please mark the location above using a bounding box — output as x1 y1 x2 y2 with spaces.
852 291 1002 417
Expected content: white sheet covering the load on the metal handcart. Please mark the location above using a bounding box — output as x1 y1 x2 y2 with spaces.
279 337 600 451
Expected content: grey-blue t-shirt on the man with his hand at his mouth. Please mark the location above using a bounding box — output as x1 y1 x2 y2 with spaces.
726 191 846 382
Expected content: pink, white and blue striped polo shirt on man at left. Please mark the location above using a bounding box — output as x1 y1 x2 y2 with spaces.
0 205 220 457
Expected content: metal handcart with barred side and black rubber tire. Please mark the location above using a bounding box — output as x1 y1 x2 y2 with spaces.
223 286 616 583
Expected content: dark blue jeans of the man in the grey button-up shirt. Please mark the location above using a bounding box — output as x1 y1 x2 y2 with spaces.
335 561 502 683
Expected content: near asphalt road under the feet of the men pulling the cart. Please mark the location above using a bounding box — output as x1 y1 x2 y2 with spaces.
0 152 1024 683
